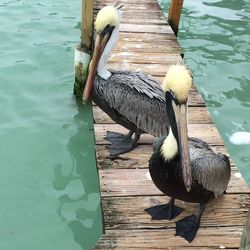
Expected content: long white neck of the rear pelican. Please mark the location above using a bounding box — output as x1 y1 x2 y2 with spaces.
97 25 119 80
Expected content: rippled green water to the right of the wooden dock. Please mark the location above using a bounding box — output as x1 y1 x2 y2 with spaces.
159 0 250 187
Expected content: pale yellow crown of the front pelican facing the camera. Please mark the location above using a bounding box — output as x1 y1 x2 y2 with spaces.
162 64 192 103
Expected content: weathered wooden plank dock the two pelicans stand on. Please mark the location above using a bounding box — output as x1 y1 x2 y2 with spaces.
94 0 250 250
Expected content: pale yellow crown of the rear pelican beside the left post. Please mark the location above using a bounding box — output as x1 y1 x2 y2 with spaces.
95 5 120 34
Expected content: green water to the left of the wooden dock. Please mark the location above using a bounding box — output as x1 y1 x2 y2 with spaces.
0 0 102 250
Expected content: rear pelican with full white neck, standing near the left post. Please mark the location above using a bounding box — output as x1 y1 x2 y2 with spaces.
83 6 169 156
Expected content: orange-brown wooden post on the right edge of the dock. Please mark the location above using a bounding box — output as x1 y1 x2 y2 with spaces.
168 0 183 36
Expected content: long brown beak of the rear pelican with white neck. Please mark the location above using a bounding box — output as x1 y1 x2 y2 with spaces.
82 32 111 103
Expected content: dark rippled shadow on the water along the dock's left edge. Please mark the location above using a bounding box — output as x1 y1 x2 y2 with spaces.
53 98 102 250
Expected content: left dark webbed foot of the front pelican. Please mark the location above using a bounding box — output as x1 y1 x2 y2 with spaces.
144 198 183 220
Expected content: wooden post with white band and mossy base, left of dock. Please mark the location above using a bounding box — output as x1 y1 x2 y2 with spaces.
74 0 94 97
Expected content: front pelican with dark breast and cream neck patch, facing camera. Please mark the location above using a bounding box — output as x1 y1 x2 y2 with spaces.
145 65 231 242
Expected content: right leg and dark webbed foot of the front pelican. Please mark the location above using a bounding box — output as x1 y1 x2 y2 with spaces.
176 204 206 242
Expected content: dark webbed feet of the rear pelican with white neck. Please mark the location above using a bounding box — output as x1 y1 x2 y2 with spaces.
107 131 140 157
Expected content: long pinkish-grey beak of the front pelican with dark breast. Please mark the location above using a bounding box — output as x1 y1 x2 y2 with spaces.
177 103 192 192
